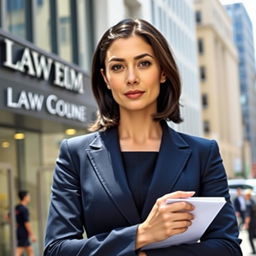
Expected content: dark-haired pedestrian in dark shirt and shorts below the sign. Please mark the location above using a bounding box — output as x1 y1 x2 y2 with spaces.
15 190 36 256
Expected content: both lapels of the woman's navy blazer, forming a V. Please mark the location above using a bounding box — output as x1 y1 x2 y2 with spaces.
87 122 191 225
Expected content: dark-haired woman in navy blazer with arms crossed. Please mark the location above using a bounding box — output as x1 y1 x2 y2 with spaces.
44 19 242 256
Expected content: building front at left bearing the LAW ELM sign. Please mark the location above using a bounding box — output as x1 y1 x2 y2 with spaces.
0 0 97 256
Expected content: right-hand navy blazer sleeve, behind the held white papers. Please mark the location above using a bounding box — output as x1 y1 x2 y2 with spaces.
145 140 242 256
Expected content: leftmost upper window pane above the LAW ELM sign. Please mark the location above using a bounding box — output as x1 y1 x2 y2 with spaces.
6 0 26 38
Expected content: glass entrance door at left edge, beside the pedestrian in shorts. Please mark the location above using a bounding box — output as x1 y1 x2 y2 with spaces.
0 163 16 256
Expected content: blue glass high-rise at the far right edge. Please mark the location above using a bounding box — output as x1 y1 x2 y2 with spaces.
225 3 256 177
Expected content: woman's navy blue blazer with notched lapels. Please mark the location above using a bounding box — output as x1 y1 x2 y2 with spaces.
44 123 242 256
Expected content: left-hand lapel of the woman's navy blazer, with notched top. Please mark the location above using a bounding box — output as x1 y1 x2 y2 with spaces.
87 128 140 225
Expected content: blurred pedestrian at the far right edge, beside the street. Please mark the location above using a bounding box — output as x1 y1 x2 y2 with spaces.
244 189 256 254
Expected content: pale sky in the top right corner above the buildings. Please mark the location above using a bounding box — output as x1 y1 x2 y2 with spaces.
220 0 256 51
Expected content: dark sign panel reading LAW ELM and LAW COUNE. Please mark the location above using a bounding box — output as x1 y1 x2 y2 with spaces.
0 29 97 128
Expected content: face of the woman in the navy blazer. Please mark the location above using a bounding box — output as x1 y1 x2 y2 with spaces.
102 35 165 113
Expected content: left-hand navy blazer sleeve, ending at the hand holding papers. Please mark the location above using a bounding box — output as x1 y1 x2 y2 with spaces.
44 140 140 256
